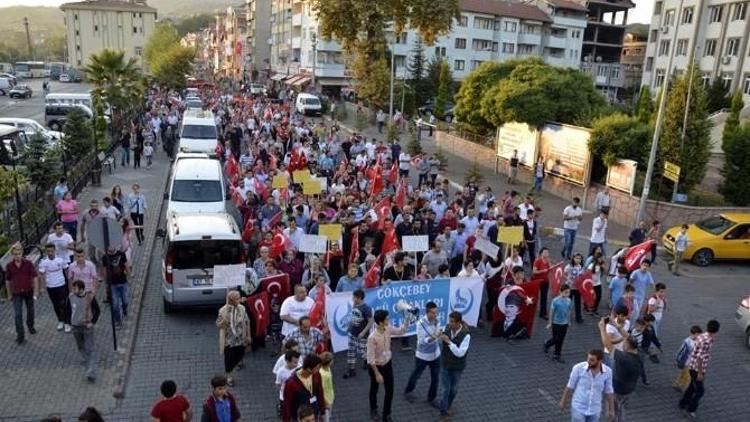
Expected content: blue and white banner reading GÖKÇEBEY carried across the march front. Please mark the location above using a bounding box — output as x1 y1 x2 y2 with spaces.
326 277 484 352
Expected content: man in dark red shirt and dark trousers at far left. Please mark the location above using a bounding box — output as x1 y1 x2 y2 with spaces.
5 245 40 344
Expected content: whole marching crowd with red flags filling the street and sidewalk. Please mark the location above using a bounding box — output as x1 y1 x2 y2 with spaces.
6 82 719 421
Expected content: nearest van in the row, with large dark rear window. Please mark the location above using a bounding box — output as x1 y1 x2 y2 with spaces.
156 214 245 313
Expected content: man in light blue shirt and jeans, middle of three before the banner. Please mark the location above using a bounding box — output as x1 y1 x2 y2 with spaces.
404 302 443 403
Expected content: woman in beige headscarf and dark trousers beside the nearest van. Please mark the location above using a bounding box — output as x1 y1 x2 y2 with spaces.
216 290 250 385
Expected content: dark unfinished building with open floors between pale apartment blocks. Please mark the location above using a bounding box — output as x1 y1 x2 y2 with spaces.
581 0 635 102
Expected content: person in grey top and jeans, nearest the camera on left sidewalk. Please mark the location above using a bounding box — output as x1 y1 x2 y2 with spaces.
68 280 99 382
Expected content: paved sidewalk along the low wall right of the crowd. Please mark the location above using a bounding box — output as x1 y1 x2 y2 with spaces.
327 113 635 252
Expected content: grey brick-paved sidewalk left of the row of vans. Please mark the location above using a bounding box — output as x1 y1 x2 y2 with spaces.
0 151 170 421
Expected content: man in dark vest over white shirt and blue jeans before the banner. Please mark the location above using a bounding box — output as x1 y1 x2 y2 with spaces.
440 311 471 421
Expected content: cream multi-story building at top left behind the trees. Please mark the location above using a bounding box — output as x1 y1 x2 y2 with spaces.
60 0 157 69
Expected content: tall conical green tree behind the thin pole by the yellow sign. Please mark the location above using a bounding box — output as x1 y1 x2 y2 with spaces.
655 64 711 192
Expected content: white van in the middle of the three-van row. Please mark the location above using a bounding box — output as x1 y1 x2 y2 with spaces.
164 153 227 215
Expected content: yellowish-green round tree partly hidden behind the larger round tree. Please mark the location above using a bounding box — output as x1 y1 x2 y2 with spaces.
456 59 542 134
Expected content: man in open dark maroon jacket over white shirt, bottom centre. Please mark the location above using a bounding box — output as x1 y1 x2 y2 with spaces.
281 355 326 422
